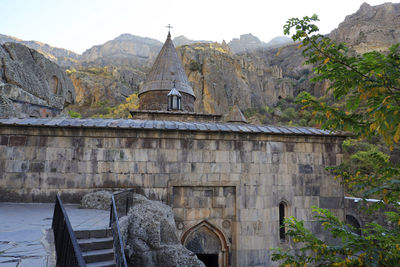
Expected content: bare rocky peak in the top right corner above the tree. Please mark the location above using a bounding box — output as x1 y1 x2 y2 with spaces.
329 3 400 53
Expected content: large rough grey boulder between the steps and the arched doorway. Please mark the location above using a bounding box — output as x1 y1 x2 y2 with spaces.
120 194 204 267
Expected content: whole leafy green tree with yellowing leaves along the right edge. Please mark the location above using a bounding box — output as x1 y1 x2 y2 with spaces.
272 15 400 266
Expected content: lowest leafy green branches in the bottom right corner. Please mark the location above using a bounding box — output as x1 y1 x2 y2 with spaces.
272 207 400 266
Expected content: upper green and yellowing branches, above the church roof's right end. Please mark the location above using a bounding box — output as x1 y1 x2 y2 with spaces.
284 15 400 149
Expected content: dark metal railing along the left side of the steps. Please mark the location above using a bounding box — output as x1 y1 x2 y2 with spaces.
51 194 86 267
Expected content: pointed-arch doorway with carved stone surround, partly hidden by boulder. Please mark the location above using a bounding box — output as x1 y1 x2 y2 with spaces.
182 221 229 267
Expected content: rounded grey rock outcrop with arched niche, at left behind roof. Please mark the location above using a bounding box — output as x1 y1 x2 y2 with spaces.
0 43 75 117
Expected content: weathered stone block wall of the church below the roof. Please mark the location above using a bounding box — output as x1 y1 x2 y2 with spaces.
0 126 344 266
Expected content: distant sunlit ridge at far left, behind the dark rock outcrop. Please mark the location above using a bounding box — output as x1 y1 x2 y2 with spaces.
0 34 80 68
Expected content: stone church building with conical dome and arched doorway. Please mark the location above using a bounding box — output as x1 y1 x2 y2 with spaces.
0 34 346 266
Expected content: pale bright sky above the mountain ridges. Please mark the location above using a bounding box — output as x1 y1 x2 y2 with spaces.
0 0 394 53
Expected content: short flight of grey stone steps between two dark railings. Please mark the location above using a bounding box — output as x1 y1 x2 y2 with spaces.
74 228 116 267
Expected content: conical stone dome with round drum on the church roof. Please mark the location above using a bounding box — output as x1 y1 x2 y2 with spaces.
139 33 195 111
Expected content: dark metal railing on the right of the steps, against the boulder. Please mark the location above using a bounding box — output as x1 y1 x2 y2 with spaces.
110 195 128 267
